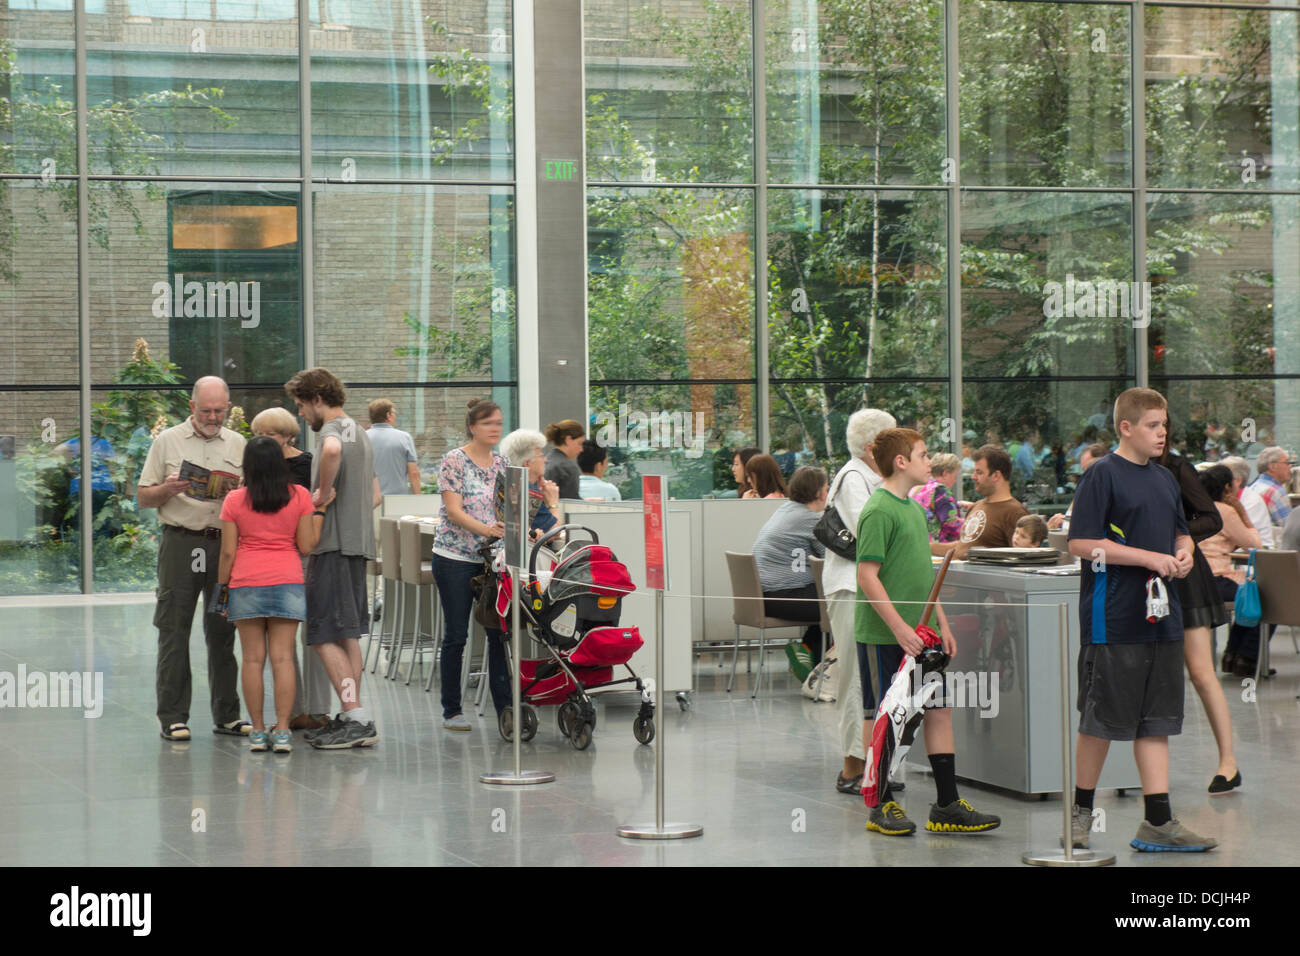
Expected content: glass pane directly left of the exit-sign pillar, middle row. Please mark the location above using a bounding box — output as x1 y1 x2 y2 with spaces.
315 185 516 403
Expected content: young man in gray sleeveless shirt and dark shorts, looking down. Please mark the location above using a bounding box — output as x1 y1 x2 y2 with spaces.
285 368 380 750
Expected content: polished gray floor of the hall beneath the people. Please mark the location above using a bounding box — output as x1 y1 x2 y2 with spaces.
0 597 1300 866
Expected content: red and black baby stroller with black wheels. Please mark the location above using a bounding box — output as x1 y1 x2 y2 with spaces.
483 524 655 750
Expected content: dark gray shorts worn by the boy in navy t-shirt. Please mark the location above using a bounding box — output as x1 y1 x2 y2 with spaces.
1079 641 1183 740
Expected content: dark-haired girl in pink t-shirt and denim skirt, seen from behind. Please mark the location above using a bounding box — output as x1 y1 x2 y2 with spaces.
217 436 329 753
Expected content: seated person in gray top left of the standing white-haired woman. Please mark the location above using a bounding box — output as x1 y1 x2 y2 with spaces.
750 459 827 683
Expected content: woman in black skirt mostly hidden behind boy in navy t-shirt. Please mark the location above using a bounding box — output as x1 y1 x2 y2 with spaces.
1157 445 1242 795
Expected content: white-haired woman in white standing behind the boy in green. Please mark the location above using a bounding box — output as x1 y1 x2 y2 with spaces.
822 408 898 793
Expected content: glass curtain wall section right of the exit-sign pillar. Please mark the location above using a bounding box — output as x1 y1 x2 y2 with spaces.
584 0 1300 511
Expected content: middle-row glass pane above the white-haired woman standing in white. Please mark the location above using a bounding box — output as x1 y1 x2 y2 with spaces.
768 190 948 458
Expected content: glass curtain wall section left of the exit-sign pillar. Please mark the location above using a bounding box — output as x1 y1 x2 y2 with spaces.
0 0 516 596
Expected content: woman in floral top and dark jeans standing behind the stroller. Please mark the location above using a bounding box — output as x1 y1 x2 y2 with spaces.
433 399 511 730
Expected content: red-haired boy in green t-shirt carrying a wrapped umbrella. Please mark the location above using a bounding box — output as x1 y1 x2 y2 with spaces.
853 428 1002 836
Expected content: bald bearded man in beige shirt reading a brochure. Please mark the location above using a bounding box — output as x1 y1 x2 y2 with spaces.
137 376 251 740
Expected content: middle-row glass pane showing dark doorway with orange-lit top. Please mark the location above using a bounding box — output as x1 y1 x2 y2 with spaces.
90 182 302 384
